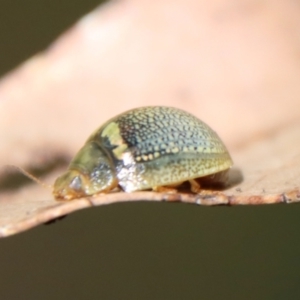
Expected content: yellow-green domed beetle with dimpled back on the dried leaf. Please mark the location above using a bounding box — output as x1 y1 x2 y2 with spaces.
53 106 232 200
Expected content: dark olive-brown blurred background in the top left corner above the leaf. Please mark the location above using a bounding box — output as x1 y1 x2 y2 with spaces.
0 0 99 75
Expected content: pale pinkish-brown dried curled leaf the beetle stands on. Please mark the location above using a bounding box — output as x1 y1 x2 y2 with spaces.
0 0 300 236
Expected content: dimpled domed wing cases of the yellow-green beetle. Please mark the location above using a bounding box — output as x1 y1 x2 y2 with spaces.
89 106 232 192
